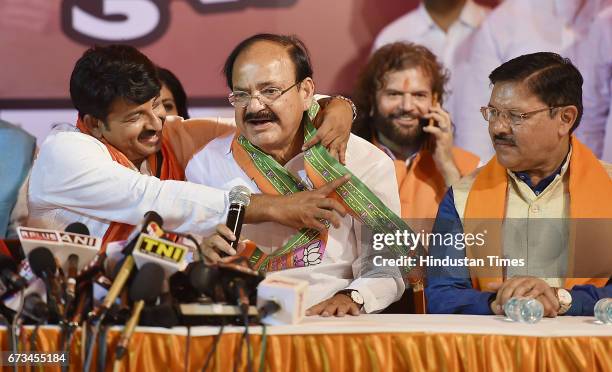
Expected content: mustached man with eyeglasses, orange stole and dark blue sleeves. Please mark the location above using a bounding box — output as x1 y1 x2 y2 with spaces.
425 52 612 317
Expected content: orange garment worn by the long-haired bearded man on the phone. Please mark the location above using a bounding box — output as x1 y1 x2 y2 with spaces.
393 147 480 219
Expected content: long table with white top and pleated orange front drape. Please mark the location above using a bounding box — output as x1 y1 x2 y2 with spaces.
1 314 612 372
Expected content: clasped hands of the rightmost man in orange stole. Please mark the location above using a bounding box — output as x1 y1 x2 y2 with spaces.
489 276 559 318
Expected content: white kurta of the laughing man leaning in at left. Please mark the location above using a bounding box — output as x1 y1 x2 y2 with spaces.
28 131 229 237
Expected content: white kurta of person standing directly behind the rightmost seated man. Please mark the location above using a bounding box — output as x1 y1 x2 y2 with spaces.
447 0 612 162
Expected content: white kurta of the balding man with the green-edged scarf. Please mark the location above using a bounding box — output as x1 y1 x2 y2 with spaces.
185 135 404 312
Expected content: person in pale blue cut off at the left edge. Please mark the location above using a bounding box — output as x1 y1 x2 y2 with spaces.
0 120 36 239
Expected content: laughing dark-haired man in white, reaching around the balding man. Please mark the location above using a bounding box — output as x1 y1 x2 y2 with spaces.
29 45 352 242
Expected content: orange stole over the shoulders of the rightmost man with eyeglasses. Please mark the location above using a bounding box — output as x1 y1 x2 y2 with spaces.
463 136 612 289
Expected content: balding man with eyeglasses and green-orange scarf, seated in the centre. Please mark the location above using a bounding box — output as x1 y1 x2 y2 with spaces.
186 34 404 316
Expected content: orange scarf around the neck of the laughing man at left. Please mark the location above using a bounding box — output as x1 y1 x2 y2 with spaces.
77 118 185 249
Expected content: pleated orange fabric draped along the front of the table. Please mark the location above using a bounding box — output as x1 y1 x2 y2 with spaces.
0 329 612 372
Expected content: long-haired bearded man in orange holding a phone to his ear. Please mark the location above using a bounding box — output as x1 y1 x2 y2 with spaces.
353 42 479 221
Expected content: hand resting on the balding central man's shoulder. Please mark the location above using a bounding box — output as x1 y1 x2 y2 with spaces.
302 97 353 164
